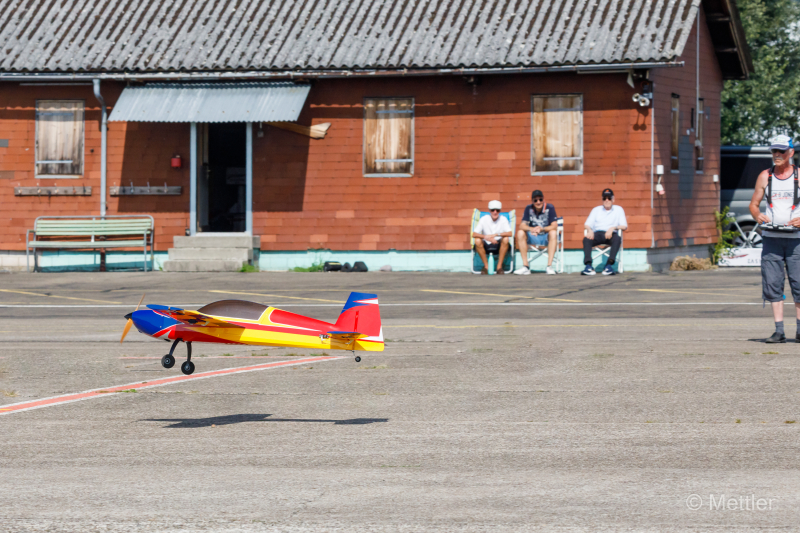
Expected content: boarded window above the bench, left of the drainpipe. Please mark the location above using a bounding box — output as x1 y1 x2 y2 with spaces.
35 100 84 177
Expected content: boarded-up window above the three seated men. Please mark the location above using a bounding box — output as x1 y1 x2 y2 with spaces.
531 95 583 174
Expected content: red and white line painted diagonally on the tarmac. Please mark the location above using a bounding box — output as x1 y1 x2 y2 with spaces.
0 356 344 415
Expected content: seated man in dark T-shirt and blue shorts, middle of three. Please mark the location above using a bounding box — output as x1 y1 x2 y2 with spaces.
514 189 558 276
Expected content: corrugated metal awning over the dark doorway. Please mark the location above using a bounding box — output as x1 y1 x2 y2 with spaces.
109 82 311 122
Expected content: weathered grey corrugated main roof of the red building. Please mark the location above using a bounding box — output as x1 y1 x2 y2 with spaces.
0 0 701 72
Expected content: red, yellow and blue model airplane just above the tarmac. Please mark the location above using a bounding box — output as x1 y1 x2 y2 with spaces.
120 292 383 375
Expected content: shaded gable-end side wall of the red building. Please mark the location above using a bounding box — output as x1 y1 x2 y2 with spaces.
648 6 722 247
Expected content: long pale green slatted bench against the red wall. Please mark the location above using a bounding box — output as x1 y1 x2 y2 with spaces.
25 215 154 272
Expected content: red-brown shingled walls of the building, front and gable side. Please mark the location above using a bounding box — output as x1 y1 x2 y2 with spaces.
0 9 722 250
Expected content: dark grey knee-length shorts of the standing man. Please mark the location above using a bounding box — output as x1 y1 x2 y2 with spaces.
761 236 800 302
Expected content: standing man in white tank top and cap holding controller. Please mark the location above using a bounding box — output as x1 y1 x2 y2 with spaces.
750 135 800 343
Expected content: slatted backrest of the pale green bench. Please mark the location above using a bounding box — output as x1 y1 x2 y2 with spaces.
34 215 153 237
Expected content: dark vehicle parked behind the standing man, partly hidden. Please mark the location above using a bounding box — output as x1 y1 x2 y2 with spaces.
720 146 798 248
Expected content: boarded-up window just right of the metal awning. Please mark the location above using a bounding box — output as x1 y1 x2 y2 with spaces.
364 98 414 177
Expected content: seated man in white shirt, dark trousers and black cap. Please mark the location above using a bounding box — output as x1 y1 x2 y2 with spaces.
581 189 628 276
